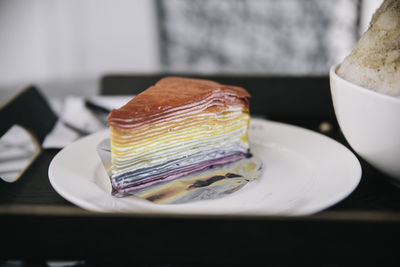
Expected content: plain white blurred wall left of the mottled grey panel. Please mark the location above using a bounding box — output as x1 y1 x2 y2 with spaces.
0 0 158 96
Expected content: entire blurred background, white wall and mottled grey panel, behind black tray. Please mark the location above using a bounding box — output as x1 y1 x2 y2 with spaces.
0 0 382 100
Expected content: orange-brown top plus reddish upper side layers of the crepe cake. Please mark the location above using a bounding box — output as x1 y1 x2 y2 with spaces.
108 77 250 128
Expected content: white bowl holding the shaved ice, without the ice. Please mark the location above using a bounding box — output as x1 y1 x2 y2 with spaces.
329 65 400 185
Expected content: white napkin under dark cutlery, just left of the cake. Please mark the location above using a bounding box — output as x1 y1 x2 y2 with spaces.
42 96 133 149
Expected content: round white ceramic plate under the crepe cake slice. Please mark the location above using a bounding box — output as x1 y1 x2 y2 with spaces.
49 119 361 218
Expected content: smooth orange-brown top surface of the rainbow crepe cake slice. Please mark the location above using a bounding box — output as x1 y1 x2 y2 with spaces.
108 77 250 125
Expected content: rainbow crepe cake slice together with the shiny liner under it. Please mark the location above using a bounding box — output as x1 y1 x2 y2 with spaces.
108 77 260 203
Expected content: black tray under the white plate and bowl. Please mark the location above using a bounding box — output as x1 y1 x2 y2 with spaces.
0 74 400 266
